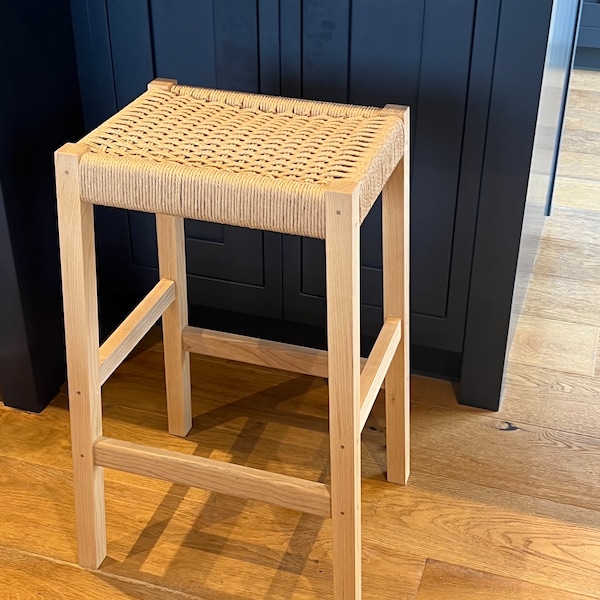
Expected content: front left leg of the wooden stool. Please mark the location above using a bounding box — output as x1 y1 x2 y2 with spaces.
56 144 106 569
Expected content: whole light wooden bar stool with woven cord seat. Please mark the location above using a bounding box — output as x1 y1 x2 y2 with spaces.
56 79 410 600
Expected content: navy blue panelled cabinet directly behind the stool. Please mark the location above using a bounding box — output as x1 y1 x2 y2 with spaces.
71 0 573 408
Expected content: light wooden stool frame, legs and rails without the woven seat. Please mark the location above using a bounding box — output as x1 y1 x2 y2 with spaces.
55 81 410 600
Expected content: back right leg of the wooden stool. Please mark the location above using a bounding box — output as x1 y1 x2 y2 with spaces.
382 111 410 484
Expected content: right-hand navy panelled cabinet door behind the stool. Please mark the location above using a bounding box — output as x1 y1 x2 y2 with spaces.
284 0 476 352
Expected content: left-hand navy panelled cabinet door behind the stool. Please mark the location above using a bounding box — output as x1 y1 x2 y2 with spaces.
75 0 282 326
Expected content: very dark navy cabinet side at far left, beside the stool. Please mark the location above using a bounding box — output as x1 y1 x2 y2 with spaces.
0 0 83 411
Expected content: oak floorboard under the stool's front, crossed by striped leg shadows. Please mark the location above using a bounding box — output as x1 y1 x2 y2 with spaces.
0 452 600 600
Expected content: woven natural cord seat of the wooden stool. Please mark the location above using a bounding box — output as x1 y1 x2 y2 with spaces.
76 79 403 238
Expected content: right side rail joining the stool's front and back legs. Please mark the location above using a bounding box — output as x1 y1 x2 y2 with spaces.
360 317 402 431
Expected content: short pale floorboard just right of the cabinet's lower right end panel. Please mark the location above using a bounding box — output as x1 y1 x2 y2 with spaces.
509 314 600 375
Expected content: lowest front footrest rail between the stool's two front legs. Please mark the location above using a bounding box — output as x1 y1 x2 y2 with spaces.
94 438 330 517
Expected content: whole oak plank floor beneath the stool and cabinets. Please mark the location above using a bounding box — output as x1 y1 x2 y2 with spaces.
0 72 600 600
